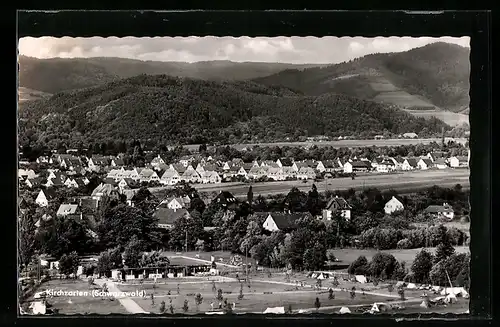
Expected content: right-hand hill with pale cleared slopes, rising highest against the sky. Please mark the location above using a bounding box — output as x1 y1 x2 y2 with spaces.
254 42 470 113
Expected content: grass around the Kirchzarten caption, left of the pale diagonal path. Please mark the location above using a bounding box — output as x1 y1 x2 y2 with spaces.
24 279 128 315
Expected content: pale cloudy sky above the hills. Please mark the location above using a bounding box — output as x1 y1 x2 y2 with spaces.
18 36 470 64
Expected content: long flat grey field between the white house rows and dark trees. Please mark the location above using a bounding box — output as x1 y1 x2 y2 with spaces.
149 169 470 197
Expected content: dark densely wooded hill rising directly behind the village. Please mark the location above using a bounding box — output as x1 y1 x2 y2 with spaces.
19 75 449 147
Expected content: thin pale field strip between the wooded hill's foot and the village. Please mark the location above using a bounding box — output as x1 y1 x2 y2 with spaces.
180 137 468 150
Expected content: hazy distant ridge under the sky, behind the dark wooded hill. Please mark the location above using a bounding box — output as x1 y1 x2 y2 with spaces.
19 56 326 93
